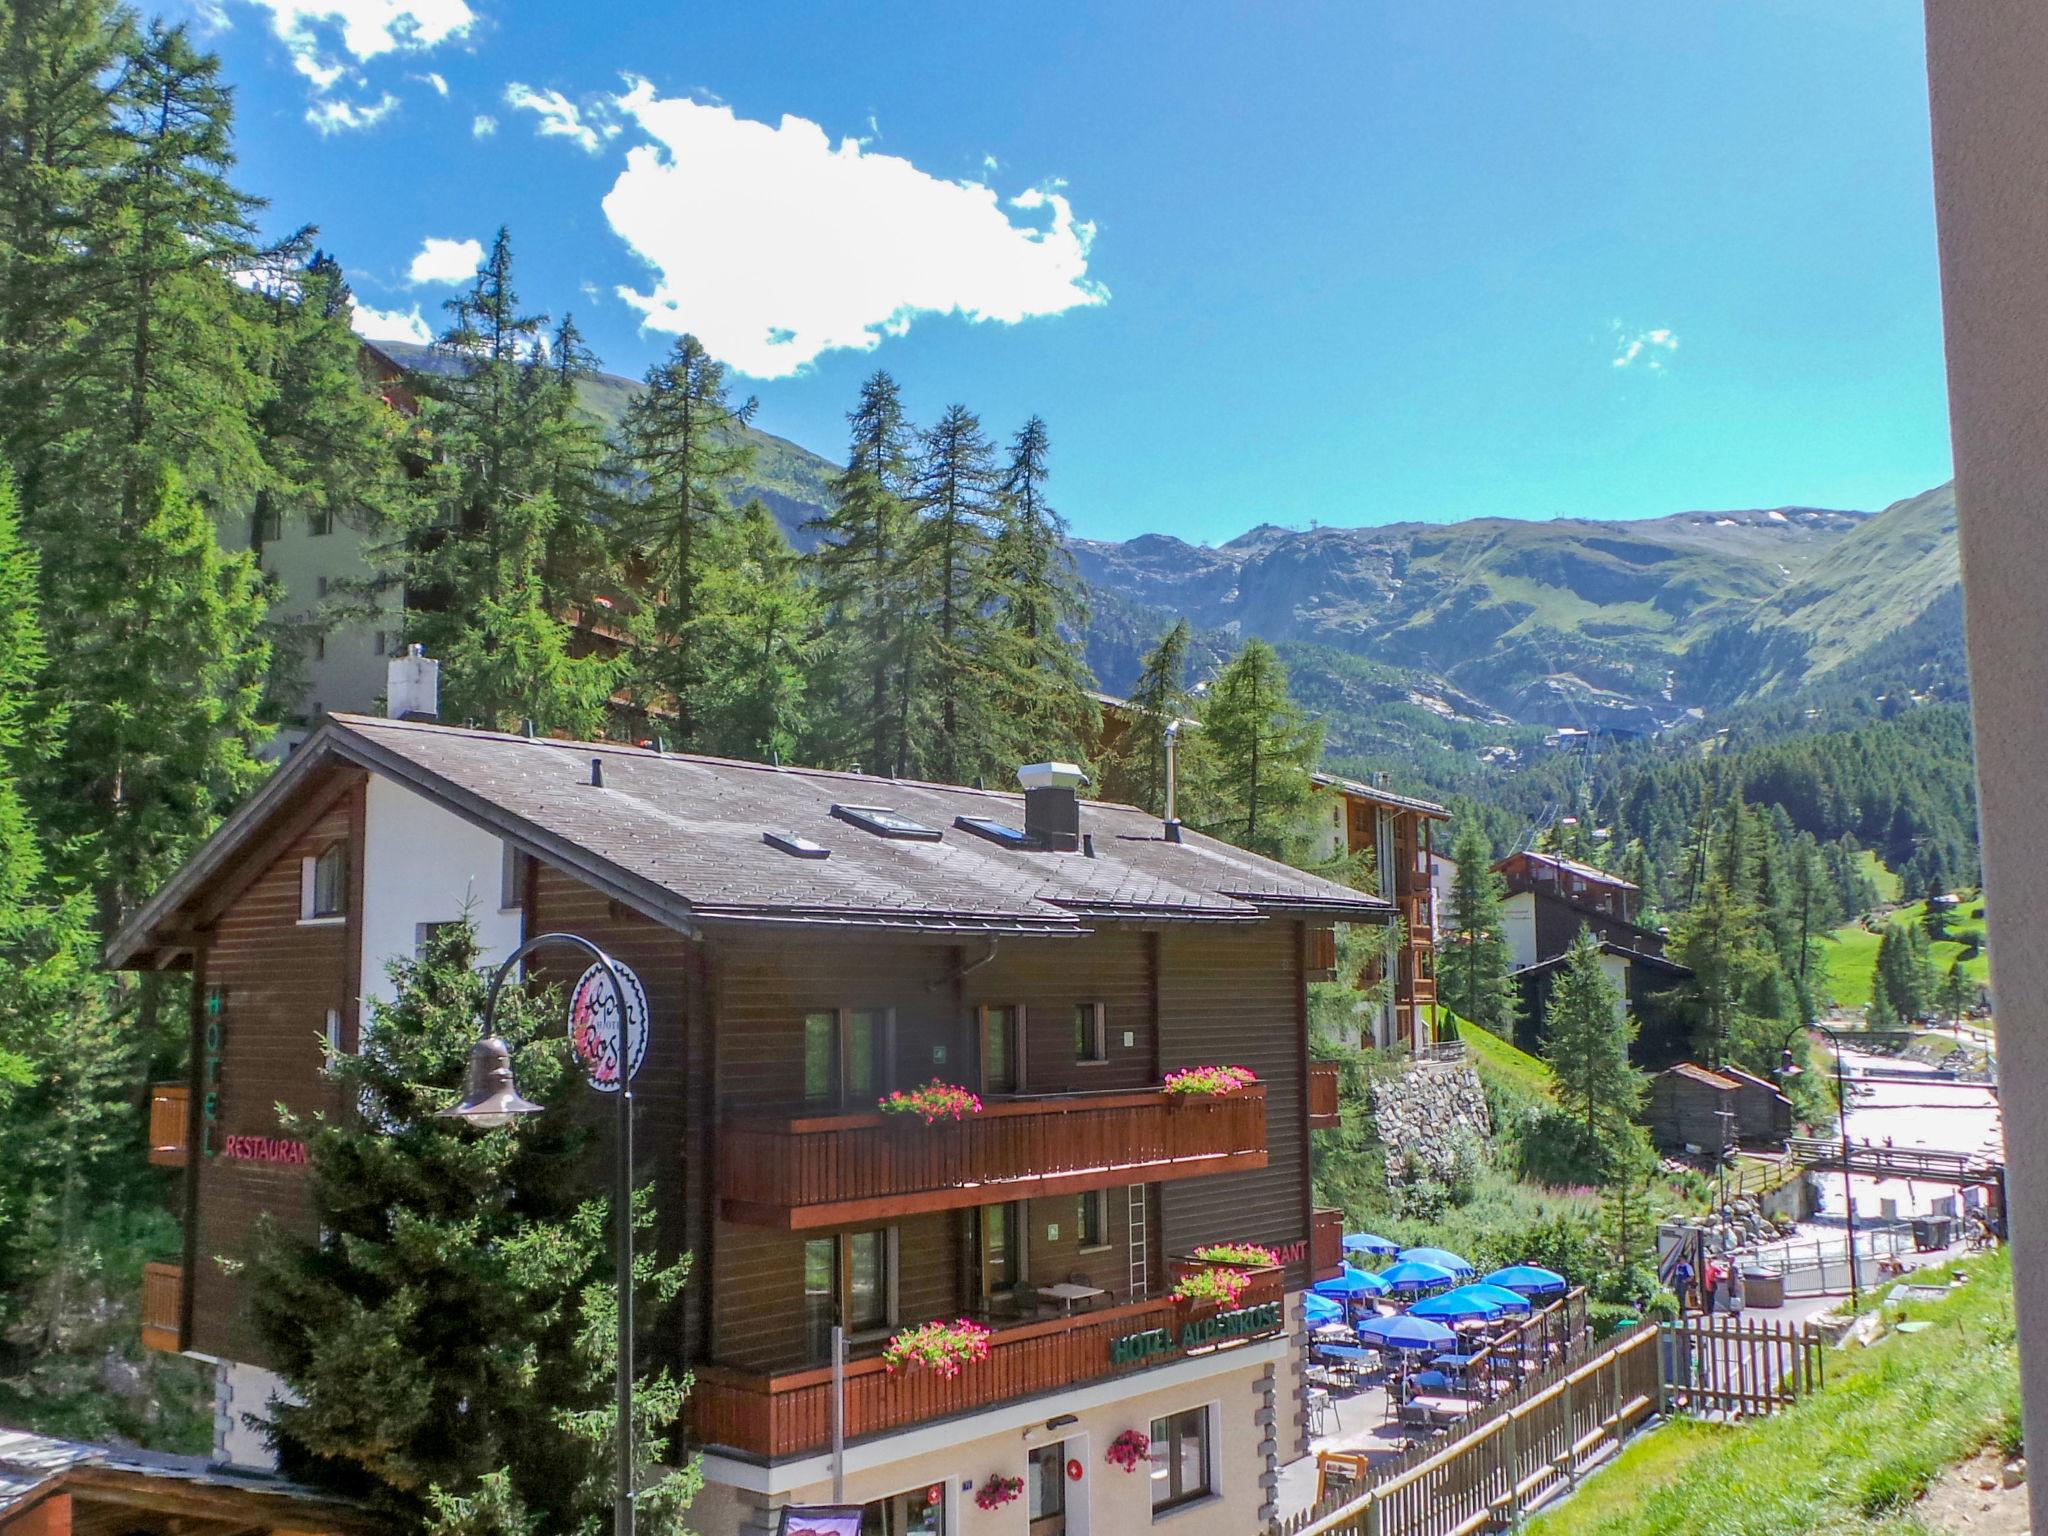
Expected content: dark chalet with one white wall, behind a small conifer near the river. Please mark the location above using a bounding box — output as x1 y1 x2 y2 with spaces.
1493 852 1692 1067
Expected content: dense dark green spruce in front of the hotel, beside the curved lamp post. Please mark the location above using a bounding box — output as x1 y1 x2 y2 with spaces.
250 920 698 1536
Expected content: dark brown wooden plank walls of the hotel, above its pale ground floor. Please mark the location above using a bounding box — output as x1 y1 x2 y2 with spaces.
136 737 1337 1482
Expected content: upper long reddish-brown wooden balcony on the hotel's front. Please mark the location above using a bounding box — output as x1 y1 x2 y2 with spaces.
719 1085 1266 1231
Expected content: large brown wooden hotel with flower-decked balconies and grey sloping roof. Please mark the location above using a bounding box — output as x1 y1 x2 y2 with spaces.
109 667 1359 1536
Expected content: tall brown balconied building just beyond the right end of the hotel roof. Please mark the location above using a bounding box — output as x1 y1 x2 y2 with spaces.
1309 774 1450 1047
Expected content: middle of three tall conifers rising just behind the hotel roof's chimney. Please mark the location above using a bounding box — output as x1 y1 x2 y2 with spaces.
899 406 1014 784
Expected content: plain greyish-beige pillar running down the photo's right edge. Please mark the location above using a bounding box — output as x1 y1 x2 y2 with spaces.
1927 0 2048 1530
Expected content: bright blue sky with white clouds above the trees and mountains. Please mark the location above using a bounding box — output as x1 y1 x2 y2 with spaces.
199 0 1950 541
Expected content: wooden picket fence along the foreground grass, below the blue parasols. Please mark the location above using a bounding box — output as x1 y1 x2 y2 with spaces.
1272 1317 1823 1536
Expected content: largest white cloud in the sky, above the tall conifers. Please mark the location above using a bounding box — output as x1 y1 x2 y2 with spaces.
604 78 1110 379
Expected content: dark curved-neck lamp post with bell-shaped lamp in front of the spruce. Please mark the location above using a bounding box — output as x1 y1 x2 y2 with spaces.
436 934 633 1536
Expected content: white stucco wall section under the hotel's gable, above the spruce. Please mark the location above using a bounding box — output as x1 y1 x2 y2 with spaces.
360 774 522 1024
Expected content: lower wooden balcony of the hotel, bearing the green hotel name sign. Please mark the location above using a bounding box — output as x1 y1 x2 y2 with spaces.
688 1270 1286 1460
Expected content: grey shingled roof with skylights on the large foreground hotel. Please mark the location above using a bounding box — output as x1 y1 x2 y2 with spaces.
109 715 1391 965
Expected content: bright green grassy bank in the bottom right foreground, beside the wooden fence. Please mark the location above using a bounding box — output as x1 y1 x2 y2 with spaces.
1528 1253 2019 1536
